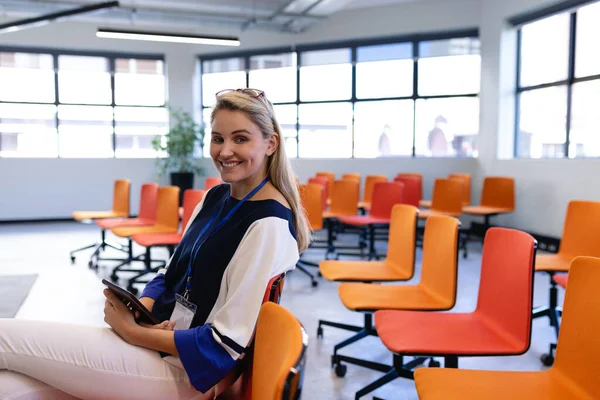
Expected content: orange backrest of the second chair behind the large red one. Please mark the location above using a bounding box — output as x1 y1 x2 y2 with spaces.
386 204 419 276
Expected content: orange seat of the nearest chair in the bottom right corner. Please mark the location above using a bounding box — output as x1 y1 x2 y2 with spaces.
415 368 580 400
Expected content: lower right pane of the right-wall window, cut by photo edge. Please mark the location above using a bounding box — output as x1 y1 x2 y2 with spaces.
569 80 600 157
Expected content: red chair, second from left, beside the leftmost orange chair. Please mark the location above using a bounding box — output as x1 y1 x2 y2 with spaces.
89 183 158 268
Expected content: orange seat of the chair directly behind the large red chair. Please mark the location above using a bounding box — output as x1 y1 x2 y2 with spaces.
338 283 454 312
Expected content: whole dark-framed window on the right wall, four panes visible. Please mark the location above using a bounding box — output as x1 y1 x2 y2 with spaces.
515 3 600 158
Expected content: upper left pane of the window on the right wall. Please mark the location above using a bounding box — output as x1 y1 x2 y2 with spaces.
521 13 570 86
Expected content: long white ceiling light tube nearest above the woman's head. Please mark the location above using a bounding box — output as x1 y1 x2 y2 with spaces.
96 28 240 46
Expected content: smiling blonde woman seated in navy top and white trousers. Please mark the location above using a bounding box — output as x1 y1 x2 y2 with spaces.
0 89 310 399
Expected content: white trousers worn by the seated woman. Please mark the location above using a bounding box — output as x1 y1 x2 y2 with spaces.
0 318 212 400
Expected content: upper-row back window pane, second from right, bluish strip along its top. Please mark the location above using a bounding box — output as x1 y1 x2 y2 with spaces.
356 43 414 99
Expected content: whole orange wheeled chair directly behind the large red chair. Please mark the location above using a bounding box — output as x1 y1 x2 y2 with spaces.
326 216 460 377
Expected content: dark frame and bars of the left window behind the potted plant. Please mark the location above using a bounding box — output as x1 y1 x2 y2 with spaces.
0 46 168 159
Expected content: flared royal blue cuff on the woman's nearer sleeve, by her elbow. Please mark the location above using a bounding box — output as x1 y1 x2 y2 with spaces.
175 324 236 393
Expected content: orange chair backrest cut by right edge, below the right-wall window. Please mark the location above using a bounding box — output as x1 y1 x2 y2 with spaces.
559 200 600 257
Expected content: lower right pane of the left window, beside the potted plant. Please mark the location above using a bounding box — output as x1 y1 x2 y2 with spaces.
115 107 169 158
